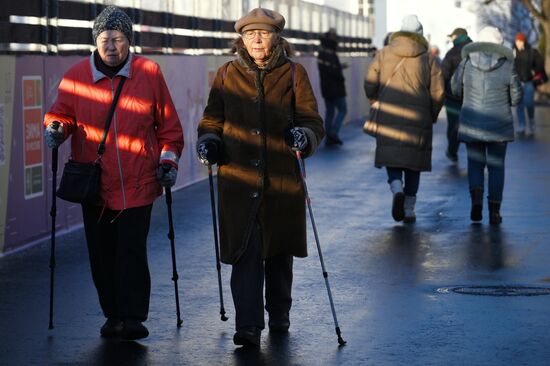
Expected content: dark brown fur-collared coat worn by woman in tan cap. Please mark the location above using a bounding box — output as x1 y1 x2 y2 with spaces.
198 39 324 264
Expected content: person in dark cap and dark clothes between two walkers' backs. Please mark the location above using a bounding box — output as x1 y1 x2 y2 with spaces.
441 28 472 163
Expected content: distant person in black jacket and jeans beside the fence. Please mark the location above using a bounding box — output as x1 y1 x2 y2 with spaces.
317 28 348 145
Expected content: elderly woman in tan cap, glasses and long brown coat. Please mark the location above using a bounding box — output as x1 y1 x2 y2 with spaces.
197 8 324 346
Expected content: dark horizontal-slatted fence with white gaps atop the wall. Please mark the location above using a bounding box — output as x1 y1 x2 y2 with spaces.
0 0 373 56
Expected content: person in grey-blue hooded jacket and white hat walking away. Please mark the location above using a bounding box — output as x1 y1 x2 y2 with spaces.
451 27 523 225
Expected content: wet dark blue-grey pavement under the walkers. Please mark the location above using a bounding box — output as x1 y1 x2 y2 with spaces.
0 107 550 366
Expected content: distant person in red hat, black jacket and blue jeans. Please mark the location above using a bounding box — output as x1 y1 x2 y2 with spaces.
514 32 547 136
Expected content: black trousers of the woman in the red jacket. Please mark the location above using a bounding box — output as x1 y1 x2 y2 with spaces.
82 205 152 321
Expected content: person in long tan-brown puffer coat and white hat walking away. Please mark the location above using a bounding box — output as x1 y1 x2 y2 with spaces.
365 15 444 223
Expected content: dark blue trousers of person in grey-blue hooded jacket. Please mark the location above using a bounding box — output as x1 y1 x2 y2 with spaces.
466 142 507 202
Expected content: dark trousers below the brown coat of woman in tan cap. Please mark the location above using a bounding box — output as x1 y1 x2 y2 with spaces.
231 224 293 330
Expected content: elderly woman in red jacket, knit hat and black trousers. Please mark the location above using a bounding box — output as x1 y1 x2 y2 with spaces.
44 6 183 339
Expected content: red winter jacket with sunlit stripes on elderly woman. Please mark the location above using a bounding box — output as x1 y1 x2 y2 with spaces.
44 53 183 210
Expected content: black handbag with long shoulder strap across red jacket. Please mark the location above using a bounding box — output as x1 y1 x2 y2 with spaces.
56 77 126 204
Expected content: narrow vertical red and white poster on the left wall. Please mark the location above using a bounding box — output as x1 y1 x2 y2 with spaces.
22 76 44 199
